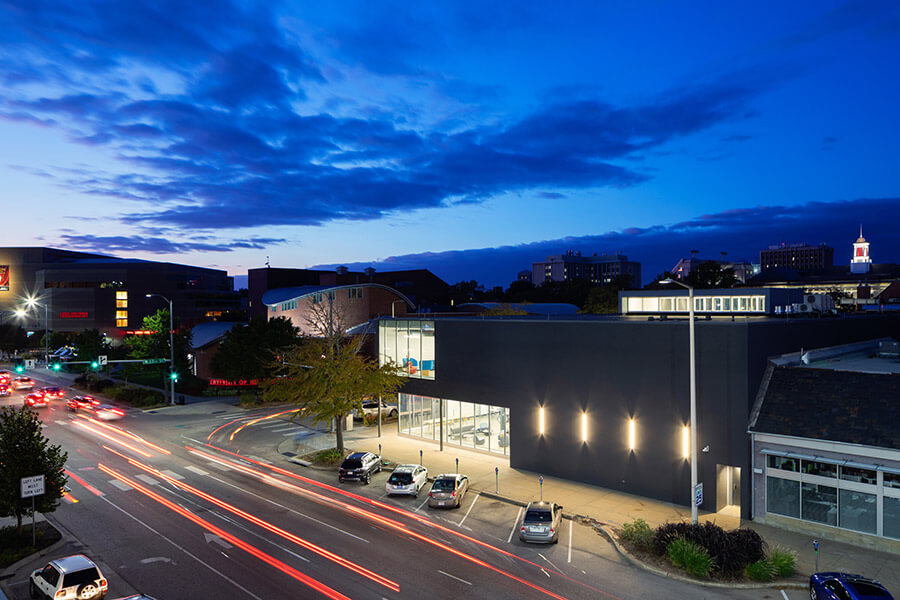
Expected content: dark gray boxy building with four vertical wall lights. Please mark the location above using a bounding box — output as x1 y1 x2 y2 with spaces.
379 310 900 518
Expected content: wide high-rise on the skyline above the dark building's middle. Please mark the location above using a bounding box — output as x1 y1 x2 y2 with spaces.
531 250 641 287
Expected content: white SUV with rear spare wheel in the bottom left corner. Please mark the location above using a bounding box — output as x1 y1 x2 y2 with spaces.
28 554 106 600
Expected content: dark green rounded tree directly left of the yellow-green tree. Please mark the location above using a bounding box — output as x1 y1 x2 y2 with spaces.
210 317 298 379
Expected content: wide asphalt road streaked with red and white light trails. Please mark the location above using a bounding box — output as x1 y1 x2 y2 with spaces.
2 374 802 600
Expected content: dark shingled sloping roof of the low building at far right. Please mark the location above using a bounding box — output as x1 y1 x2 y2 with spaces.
750 367 900 450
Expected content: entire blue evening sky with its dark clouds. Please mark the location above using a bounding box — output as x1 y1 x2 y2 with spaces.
0 0 900 285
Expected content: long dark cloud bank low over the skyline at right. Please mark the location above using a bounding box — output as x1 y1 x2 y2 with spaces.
318 198 900 286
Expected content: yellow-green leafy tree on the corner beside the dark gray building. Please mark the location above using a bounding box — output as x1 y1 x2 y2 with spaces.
263 337 404 456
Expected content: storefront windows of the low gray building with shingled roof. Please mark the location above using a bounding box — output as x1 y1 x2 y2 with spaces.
766 454 900 539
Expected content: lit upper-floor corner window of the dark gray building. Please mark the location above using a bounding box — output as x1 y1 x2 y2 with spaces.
378 319 436 379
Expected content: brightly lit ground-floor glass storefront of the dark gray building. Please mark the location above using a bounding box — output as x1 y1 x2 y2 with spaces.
398 394 509 455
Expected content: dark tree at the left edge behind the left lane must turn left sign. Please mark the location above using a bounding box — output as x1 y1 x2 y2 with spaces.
0 406 68 535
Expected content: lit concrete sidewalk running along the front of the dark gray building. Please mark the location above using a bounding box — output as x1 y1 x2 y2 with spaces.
344 423 900 595
